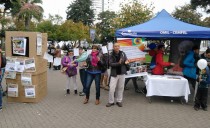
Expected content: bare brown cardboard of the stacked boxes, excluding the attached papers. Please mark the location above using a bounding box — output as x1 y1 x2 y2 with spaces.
5 31 47 102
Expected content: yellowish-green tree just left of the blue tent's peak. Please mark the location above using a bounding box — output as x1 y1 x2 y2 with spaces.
113 0 154 28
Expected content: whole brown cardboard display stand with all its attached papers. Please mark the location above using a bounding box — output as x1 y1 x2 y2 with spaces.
5 31 47 102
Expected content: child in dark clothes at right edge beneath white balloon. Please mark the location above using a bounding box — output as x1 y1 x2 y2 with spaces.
194 66 210 111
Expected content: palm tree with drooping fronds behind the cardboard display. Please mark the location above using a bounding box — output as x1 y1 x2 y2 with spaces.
12 0 44 30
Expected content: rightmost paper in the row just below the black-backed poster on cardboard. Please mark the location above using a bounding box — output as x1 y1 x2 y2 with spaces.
25 58 36 72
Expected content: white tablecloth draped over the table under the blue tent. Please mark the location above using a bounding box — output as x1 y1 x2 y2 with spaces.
146 75 190 102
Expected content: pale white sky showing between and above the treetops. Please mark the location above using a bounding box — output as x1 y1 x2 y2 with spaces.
42 0 194 19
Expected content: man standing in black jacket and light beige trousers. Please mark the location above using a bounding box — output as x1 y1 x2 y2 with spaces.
106 43 129 107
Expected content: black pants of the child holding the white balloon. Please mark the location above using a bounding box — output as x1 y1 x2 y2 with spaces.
194 88 208 108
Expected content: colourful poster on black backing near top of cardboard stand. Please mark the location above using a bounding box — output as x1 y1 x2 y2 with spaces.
12 37 27 56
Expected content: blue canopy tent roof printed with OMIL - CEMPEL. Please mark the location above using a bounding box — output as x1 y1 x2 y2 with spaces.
115 9 210 39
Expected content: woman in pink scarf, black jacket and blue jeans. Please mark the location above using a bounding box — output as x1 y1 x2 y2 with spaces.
83 45 103 105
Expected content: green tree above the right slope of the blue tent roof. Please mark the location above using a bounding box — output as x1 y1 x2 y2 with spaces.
172 4 203 25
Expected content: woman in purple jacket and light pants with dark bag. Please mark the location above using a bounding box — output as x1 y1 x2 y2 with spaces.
62 49 78 94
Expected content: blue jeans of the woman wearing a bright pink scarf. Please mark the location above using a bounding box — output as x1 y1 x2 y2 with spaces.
86 73 101 100
